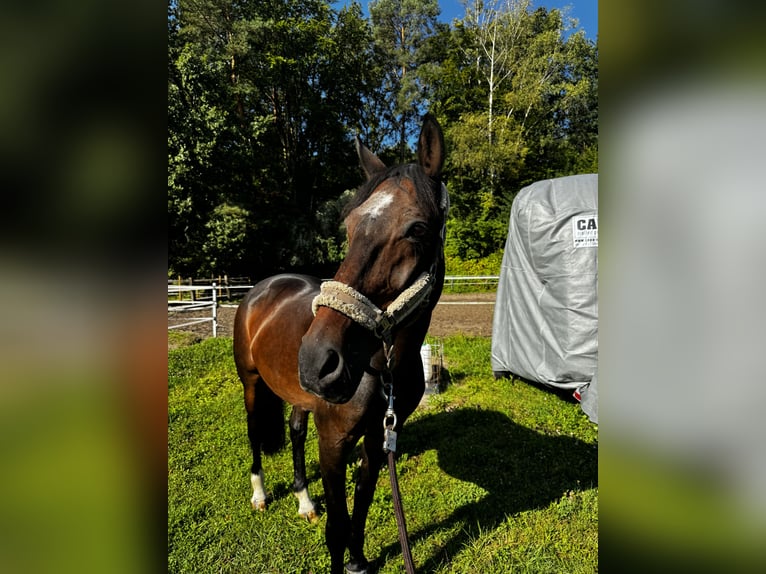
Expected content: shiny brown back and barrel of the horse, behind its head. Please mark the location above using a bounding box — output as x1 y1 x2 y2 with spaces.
234 274 321 407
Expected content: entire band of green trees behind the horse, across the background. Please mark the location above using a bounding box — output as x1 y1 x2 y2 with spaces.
168 0 598 279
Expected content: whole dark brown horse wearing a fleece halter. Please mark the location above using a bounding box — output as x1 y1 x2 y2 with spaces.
234 116 448 573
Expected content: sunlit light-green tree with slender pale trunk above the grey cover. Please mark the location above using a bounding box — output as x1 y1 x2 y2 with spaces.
435 0 598 258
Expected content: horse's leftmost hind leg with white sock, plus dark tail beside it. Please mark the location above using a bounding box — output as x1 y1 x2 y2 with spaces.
243 374 285 511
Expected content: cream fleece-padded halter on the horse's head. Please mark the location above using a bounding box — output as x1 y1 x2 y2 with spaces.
311 184 449 347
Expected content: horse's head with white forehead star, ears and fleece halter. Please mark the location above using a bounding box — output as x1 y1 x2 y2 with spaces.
298 115 448 403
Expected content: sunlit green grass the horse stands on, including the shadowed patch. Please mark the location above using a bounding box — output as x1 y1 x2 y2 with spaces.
168 337 598 574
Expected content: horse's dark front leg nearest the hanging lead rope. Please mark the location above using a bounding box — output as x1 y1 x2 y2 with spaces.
346 431 385 574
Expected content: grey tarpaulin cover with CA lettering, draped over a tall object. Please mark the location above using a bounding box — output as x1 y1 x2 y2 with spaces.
492 174 598 422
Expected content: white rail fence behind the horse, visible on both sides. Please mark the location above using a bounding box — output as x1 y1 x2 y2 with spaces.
168 275 500 337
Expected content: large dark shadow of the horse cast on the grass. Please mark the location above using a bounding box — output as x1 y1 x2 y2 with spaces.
373 409 598 573
